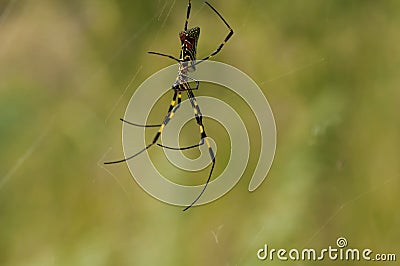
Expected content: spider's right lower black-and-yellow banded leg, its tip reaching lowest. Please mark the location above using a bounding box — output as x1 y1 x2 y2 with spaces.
183 90 215 211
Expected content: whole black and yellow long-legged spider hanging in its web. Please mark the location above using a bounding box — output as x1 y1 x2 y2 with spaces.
104 0 233 211
